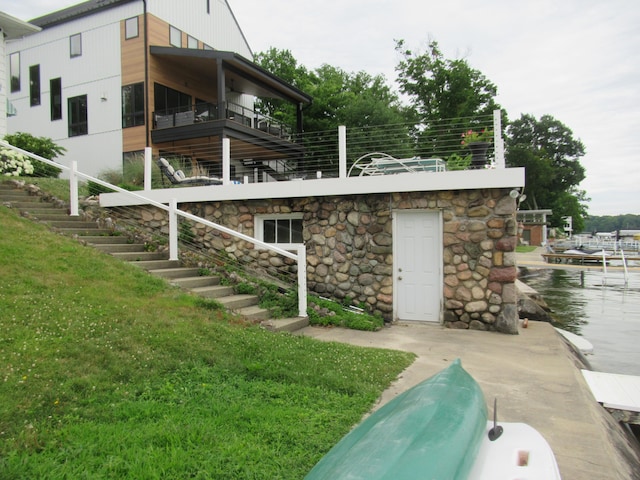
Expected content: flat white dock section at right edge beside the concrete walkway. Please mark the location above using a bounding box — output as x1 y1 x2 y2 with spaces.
582 370 640 425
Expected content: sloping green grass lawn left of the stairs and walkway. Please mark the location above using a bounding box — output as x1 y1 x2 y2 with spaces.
0 206 413 479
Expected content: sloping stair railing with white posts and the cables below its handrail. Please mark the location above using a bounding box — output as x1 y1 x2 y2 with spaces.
0 141 307 317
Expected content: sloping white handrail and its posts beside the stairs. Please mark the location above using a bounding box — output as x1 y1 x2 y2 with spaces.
0 140 307 317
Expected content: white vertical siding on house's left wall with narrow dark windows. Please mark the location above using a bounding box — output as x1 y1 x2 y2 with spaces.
7 2 142 175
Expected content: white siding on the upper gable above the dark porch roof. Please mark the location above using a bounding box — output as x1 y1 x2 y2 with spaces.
147 0 253 60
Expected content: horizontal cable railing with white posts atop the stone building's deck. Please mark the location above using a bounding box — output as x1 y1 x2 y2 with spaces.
148 112 504 183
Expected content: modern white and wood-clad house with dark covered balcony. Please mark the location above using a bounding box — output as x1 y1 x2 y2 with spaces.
5 0 311 176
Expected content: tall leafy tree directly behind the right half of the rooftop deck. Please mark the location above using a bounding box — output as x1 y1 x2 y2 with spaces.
396 40 507 157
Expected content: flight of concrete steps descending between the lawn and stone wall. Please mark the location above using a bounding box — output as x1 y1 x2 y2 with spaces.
0 183 308 331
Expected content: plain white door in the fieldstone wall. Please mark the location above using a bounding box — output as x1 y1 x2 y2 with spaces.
393 210 442 322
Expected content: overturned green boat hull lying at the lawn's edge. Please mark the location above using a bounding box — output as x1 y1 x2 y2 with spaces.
305 360 487 480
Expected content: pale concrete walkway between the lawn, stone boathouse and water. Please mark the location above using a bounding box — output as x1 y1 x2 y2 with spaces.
298 322 640 480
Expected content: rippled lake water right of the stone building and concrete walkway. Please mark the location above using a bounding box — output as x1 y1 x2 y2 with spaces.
520 269 640 376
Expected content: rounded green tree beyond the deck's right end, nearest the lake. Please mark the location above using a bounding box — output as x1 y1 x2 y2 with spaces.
505 114 589 232
